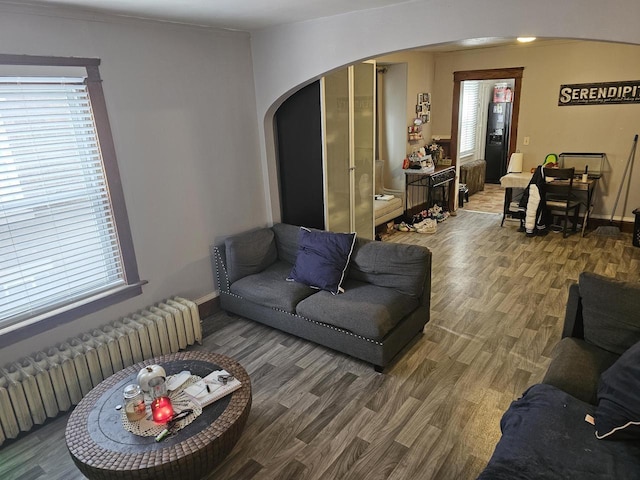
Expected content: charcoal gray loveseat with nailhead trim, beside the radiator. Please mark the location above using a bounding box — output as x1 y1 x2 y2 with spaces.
212 224 431 371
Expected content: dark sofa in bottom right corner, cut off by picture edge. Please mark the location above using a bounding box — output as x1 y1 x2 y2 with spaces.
479 273 640 480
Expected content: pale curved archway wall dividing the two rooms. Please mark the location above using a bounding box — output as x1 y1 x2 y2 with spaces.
251 0 640 223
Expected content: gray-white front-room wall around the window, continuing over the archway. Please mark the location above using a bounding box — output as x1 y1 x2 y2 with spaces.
0 0 640 364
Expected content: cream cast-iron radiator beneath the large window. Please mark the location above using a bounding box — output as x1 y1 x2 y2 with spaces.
0 297 202 445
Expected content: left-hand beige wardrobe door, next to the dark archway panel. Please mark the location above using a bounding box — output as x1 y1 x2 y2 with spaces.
322 68 353 232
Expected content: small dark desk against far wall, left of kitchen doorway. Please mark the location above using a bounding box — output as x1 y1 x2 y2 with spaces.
404 166 456 217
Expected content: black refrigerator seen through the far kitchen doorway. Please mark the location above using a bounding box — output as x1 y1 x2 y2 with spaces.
484 102 511 183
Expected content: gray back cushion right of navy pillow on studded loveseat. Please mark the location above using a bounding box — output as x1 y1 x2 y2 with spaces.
349 239 431 298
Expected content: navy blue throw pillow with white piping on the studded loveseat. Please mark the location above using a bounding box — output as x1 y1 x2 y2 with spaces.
289 227 356 295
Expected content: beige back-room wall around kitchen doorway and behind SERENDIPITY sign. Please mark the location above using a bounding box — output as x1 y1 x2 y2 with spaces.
434 40 640 221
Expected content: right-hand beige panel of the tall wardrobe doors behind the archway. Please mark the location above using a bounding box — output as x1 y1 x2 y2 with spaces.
351 63 376 239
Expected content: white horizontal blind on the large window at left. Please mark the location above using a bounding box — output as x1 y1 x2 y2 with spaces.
0 77 126 325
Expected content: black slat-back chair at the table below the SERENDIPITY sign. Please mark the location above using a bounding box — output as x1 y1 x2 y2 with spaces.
544 168 581 237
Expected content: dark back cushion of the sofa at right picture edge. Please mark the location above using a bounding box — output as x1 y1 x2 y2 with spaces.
578 272 640 355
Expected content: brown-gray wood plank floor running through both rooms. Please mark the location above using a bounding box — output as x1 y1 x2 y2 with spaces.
0 210 640 480
